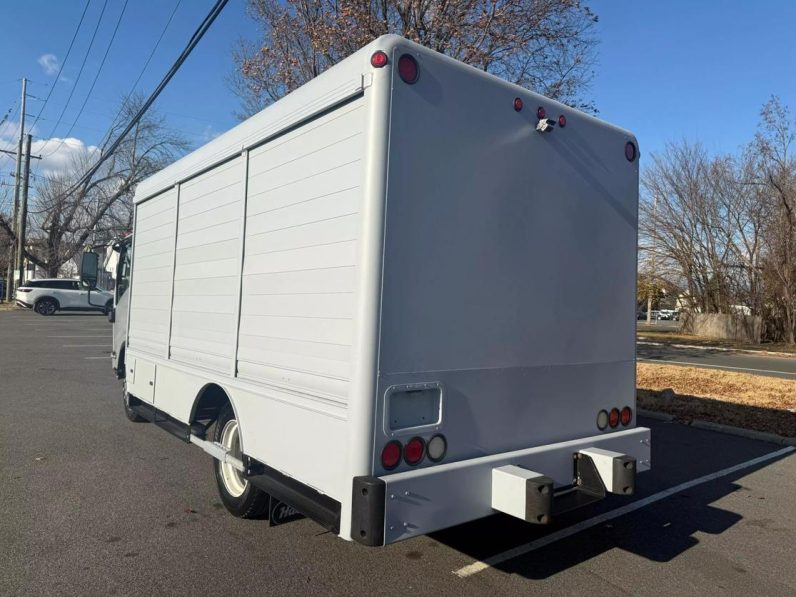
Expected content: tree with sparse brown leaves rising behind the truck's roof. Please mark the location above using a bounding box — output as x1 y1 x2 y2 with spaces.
232 0 597 116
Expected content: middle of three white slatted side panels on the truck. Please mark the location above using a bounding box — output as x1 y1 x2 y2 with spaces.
170 157 245 373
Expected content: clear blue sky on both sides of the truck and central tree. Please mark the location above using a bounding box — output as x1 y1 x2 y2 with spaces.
0 0 796 182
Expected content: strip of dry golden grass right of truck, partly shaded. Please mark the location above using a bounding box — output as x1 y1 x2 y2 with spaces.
636 363 796 437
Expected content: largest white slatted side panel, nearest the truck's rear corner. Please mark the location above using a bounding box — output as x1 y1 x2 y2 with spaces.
237 99 365 406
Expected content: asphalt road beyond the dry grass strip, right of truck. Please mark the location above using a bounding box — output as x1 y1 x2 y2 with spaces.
636 340 796 379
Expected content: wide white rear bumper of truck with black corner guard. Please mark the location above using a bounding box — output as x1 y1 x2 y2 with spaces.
352 427 651 545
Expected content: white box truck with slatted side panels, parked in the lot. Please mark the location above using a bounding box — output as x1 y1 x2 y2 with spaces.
95 36 650 545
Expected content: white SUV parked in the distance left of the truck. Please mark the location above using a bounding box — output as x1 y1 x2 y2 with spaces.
15 278 113 315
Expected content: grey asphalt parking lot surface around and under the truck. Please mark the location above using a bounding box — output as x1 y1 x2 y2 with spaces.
0 311 796 596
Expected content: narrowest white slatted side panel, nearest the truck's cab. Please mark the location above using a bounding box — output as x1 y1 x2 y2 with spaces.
128 189 177 356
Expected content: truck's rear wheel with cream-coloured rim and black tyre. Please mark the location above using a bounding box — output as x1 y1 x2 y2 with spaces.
213 404 269 518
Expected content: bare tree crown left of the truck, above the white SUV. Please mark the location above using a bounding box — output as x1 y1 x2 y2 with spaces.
0 97 188 276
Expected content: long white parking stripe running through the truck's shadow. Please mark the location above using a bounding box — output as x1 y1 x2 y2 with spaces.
453 446 796 578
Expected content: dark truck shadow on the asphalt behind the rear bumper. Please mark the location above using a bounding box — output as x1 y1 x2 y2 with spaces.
431 422 787 580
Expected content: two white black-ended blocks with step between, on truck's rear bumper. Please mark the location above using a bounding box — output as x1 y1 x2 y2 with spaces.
492 448 636 524
